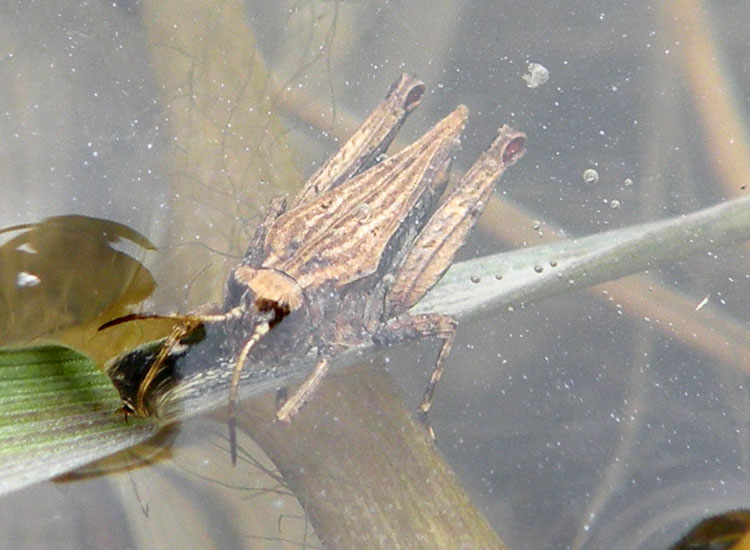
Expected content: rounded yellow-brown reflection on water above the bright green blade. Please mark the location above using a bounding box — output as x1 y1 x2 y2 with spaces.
0 215 156 356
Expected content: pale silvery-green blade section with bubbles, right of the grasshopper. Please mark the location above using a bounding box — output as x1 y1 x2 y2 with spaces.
412 197 750 319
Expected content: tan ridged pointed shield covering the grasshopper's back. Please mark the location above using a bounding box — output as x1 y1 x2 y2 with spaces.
264 106 467 288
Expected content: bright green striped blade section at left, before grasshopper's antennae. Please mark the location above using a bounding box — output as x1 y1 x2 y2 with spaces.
0 346 155 494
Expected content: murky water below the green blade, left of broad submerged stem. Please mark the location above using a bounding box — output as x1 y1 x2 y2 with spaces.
0 417 321 550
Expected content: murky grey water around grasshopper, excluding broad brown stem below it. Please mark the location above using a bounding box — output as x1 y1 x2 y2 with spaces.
0 0 750 549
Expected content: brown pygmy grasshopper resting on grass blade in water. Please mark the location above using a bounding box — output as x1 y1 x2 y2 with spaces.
105 75 526 462
